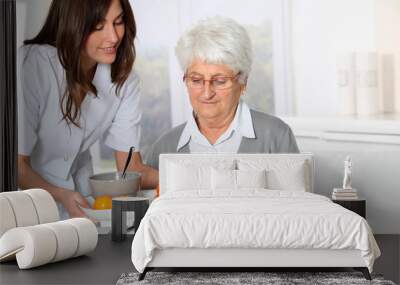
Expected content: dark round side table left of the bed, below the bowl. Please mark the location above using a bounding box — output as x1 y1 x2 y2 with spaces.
111 196 150 241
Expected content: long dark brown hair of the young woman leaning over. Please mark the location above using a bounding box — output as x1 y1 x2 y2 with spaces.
24 0 136 127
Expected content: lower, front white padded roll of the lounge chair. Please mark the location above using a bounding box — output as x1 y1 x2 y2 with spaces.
0 218 98 269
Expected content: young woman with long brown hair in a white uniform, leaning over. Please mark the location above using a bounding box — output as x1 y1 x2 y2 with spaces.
18 0 157 218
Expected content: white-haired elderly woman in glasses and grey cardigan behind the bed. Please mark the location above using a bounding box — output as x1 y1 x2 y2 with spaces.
147 17 299 169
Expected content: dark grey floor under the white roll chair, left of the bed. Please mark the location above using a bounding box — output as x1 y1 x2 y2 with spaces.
0 235 135 285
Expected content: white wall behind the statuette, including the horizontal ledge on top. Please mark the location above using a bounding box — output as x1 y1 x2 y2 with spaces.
282 117 400 234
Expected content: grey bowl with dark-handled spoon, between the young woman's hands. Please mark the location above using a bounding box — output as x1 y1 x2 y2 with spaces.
89 171 142 198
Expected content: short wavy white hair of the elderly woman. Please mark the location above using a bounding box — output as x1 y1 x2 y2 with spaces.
175 16 252 83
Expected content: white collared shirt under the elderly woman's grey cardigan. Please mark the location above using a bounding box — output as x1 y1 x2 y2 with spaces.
177 100 256 153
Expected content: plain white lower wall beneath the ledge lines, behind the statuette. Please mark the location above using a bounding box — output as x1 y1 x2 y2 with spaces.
297 135 400 234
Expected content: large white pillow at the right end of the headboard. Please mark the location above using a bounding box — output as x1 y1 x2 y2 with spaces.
237 158 311 191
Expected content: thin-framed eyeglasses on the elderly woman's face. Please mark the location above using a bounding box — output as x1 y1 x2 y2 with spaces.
183 72 240 90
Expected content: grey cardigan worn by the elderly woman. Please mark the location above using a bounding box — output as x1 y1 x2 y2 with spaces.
144 110 299 169
